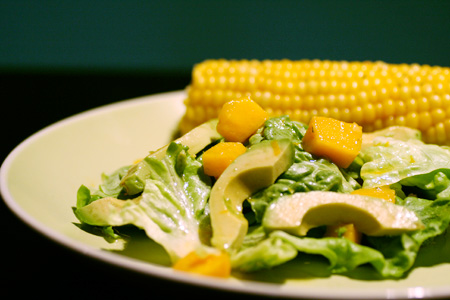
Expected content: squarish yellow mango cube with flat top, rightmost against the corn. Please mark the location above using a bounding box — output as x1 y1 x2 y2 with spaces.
302 116 362 168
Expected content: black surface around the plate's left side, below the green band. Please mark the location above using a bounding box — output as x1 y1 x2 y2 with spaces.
0 73 270 299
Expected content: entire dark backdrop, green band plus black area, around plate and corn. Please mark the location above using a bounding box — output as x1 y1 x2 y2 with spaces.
0 0 450 300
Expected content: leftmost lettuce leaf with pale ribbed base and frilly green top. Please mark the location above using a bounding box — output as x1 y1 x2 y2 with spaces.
75 143 211 261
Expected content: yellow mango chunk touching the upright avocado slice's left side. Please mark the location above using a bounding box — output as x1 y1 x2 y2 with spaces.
202 142 247 178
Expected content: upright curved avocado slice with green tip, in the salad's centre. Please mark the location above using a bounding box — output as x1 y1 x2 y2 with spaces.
209 139 294 251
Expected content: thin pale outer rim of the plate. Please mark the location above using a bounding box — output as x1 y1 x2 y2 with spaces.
0 90 450 299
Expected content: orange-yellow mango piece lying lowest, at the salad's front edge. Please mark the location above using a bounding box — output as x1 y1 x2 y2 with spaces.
173 251 231 278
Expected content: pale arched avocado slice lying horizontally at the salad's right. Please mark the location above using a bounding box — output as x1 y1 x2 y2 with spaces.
263 191 424 236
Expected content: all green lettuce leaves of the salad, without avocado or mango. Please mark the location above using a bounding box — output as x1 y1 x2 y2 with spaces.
74 116 450 278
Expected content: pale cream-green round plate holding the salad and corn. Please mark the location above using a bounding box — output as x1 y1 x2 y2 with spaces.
0 91 450 299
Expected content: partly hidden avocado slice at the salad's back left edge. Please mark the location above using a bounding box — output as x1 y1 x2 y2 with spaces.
120 119 222 195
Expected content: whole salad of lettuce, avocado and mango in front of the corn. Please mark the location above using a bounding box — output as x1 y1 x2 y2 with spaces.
73 99 450 278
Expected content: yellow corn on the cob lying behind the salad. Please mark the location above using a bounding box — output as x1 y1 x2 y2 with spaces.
180 60 450 145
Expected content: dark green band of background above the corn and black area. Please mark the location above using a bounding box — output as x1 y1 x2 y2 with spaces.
0 0 450 74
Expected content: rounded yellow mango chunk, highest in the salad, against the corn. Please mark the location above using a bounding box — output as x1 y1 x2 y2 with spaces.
217 98 269 143
